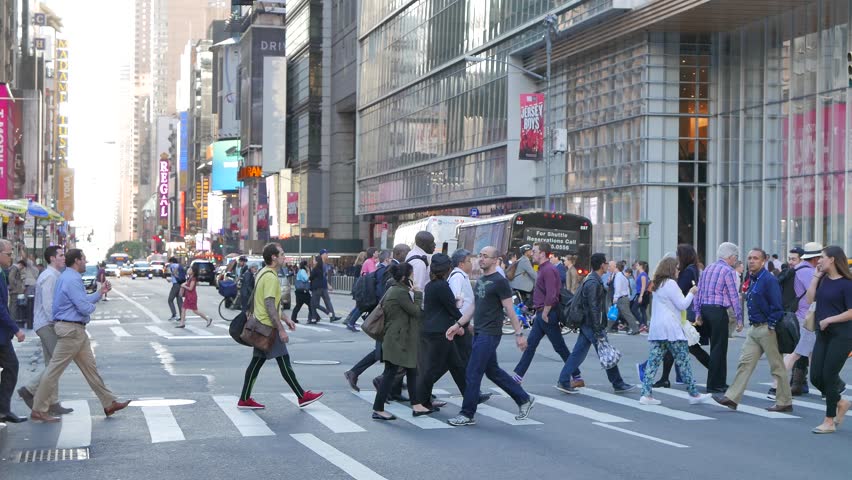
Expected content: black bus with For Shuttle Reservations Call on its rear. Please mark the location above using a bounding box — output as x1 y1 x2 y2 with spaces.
457 210 592 276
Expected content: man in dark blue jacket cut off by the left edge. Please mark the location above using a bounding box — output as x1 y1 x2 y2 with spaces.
0 239 26 423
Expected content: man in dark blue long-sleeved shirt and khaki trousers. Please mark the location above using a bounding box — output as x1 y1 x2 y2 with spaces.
713 248 793 412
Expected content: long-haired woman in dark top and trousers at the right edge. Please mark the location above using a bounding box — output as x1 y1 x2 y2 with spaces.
807 245 852 433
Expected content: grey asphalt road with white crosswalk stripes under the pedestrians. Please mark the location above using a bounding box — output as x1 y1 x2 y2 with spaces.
0 279 852 480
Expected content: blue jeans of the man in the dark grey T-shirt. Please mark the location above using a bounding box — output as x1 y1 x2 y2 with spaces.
461 334 530 418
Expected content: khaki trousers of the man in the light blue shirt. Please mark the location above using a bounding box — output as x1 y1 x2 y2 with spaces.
33 322 116 412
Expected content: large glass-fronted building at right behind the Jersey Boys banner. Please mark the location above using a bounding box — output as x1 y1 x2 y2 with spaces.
357 0 852 264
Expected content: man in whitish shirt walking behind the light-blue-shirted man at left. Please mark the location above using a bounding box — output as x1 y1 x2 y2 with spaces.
18 245 74 416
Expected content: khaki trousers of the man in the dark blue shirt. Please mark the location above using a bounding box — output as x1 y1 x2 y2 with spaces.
725 323 793 407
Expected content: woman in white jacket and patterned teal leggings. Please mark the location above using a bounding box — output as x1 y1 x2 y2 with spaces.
639 257 710 405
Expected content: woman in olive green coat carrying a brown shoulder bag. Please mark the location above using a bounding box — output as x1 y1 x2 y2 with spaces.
373 263 423 420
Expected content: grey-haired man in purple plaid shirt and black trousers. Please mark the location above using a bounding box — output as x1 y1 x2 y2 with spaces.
693 242 743 393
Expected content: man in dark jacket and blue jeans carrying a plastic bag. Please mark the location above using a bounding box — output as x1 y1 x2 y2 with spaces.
556 253 636 393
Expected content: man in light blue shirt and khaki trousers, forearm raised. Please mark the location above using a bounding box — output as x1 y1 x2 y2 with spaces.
30 248 130 423
